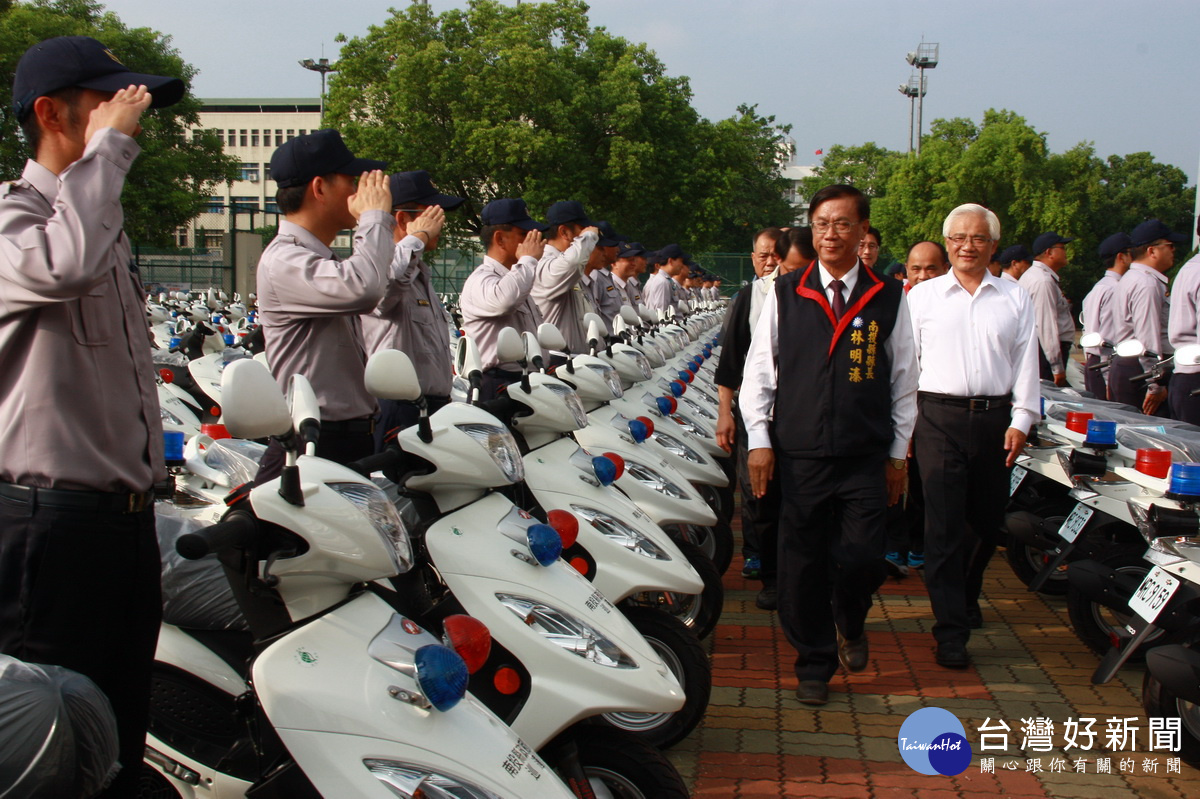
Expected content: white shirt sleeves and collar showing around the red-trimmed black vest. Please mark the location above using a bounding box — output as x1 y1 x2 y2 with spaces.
738 263 917 458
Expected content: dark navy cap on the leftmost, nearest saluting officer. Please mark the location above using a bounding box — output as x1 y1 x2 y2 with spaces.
12 36 186 121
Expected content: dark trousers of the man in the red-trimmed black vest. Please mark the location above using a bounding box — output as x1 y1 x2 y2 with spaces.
776 450 887 681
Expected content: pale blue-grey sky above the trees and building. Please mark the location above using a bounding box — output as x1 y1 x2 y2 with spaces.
106 0 1200 184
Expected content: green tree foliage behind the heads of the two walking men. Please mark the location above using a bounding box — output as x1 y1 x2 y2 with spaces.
805 109 1195 302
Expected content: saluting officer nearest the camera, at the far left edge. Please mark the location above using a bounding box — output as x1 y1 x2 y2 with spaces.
0 36 184 797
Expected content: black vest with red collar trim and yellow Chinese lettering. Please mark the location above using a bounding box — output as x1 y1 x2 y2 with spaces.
773 262 904 458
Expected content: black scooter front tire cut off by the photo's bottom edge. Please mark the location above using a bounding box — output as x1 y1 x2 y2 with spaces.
576 726 691 799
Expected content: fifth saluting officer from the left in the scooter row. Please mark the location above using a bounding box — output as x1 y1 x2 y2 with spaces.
530 200 600 353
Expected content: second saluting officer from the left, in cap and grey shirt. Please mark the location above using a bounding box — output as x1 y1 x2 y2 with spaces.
256 130 396 482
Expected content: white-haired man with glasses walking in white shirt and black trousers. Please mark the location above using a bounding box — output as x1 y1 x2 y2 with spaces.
908 204 1040 668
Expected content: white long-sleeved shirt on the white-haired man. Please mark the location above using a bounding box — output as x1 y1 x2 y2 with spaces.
908 270 1042 433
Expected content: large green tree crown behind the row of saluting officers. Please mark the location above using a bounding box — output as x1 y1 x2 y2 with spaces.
325 0 791 250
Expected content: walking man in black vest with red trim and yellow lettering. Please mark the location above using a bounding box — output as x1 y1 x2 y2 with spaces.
740 185 917 704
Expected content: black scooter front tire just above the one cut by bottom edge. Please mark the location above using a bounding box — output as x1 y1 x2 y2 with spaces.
604 607 713 751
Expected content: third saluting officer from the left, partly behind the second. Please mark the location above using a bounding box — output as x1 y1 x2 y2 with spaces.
362 169 466 450
